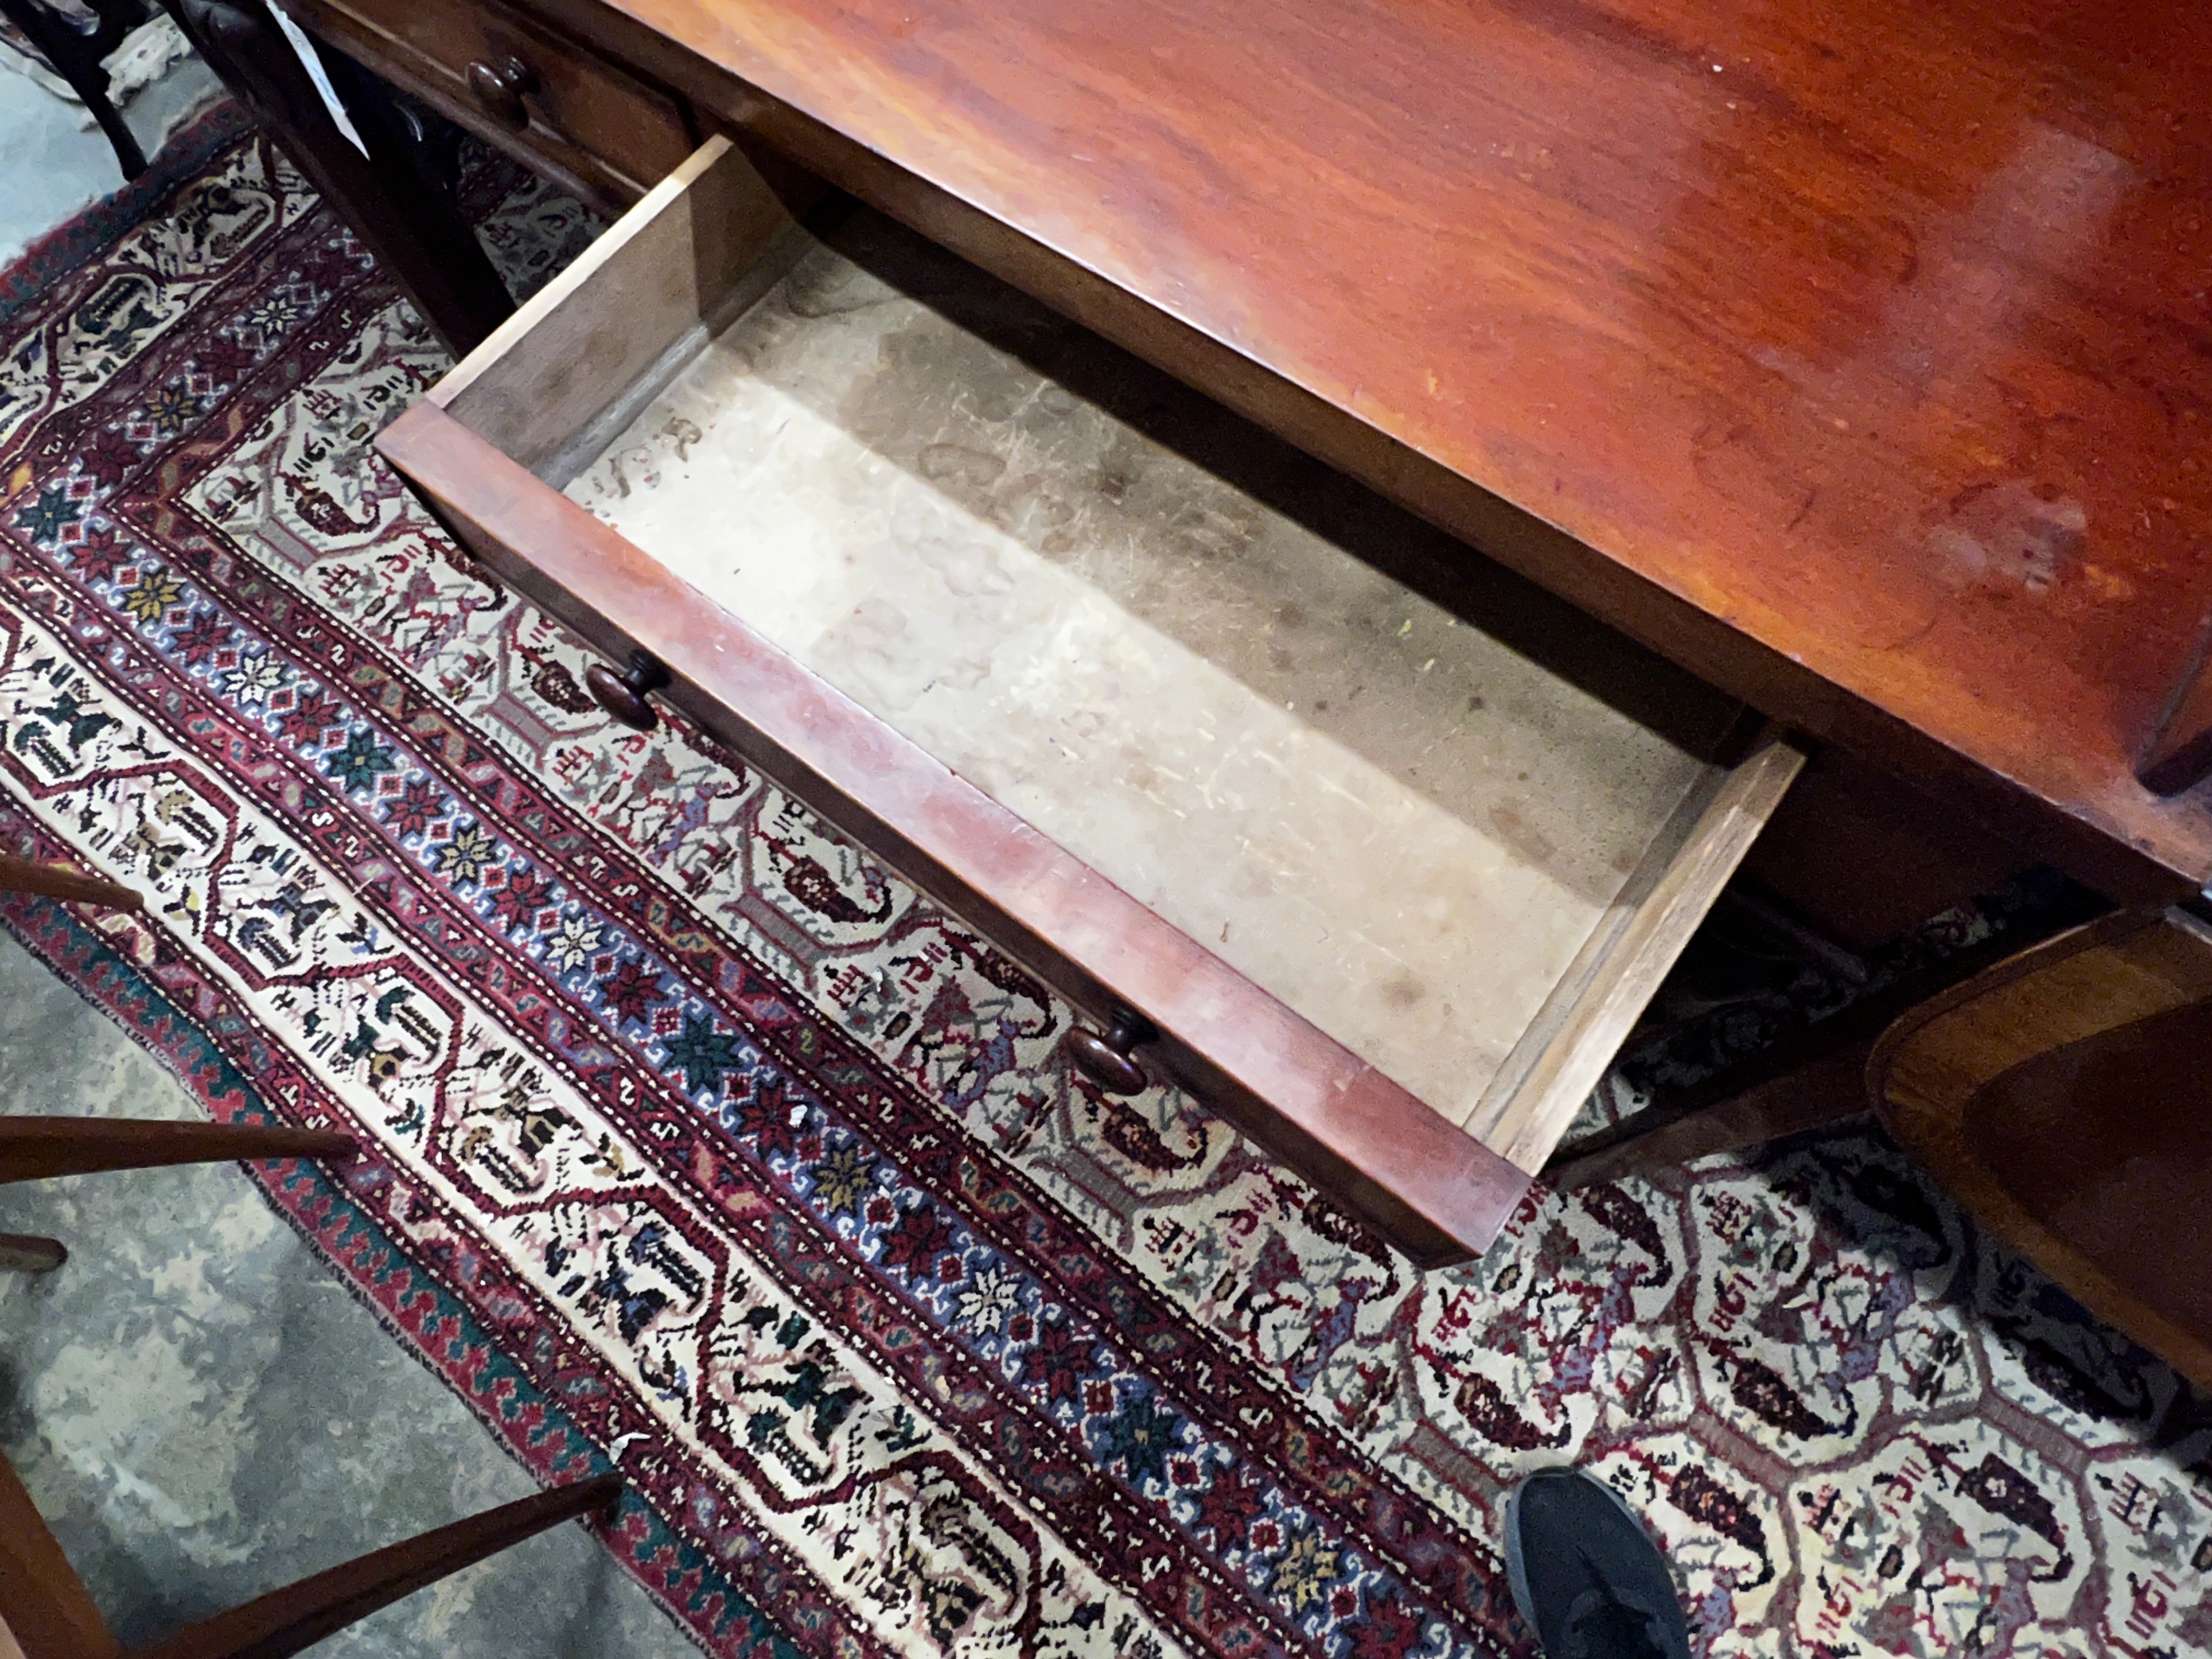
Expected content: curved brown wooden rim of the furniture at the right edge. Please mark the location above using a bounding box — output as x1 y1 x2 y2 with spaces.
1865 912 2212 1389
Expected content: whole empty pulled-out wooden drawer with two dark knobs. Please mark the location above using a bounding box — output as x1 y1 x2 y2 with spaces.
378 139 1803 1263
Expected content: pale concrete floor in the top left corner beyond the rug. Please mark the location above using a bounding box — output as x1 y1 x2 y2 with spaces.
0 49 221 266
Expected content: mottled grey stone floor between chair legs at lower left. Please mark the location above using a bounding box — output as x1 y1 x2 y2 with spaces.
0 936 694 1659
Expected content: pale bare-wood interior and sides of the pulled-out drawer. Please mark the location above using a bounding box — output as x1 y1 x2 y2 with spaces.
418 141 1794 1194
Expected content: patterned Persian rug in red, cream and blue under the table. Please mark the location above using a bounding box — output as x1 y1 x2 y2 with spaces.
0 107 2212 1659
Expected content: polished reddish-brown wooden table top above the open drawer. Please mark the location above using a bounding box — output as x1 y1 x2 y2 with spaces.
579 0 2212 898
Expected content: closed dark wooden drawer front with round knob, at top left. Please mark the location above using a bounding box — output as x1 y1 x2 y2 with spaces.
294 0 692 208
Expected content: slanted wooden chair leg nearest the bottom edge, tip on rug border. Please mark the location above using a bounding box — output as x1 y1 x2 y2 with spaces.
131 1475 622 1659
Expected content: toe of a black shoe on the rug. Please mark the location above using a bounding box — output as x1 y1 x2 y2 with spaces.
1506 1469 1690 1659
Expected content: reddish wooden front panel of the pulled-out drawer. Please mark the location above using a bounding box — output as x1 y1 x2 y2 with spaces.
376 402 1528 1265
